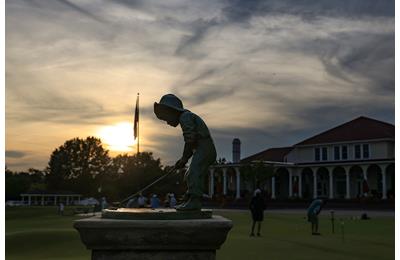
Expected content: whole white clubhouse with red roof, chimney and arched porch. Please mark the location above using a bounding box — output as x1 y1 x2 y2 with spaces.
208 117 395 200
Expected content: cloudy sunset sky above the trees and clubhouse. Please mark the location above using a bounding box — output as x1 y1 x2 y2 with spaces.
6 0 395 170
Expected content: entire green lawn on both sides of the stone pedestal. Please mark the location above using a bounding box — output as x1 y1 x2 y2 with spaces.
6 207 394 260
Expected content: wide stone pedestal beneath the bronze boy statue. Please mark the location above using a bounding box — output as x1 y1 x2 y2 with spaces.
74 209 232 260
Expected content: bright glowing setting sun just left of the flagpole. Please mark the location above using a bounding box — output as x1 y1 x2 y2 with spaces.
98 122 136 152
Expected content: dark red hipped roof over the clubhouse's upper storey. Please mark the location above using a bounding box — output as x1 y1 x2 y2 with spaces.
295 116 395 146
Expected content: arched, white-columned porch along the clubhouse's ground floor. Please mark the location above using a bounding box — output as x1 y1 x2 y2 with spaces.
207 161 395 200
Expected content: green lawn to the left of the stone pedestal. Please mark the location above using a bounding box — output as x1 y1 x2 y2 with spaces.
5 207 90 260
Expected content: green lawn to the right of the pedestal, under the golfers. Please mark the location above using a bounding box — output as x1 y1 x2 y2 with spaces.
217 213 395 260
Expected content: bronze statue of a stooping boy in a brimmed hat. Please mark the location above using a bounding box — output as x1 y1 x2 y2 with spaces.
154 94 217 210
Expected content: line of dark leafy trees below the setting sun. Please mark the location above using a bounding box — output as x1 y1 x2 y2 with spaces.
5 137 186 201
